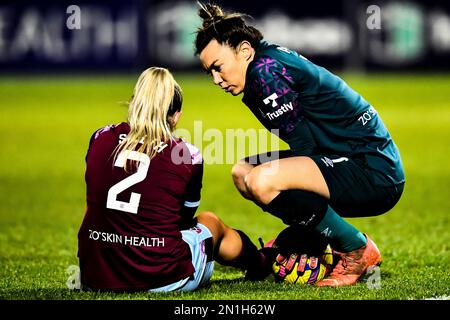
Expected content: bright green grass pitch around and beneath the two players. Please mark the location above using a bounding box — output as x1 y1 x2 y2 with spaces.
0 74 450 300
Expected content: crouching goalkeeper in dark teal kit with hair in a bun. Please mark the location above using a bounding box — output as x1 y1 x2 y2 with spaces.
195 4 405 286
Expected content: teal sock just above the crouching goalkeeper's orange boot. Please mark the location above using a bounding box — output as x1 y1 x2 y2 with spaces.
315 206 367 252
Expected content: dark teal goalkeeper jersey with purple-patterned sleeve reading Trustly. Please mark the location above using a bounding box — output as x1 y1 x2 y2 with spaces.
242 41 405 185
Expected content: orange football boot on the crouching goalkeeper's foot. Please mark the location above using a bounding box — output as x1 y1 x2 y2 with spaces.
317 234 382 287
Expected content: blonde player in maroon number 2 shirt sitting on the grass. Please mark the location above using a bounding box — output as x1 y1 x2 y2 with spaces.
78 67 261 291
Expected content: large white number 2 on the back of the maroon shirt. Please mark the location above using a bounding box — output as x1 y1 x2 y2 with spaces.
106 150 150 214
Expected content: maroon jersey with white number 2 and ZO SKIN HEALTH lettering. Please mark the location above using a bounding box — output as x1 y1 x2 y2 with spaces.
78 123 203 290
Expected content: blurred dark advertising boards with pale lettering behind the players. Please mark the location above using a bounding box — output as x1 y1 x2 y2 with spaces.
0 0 450 72
